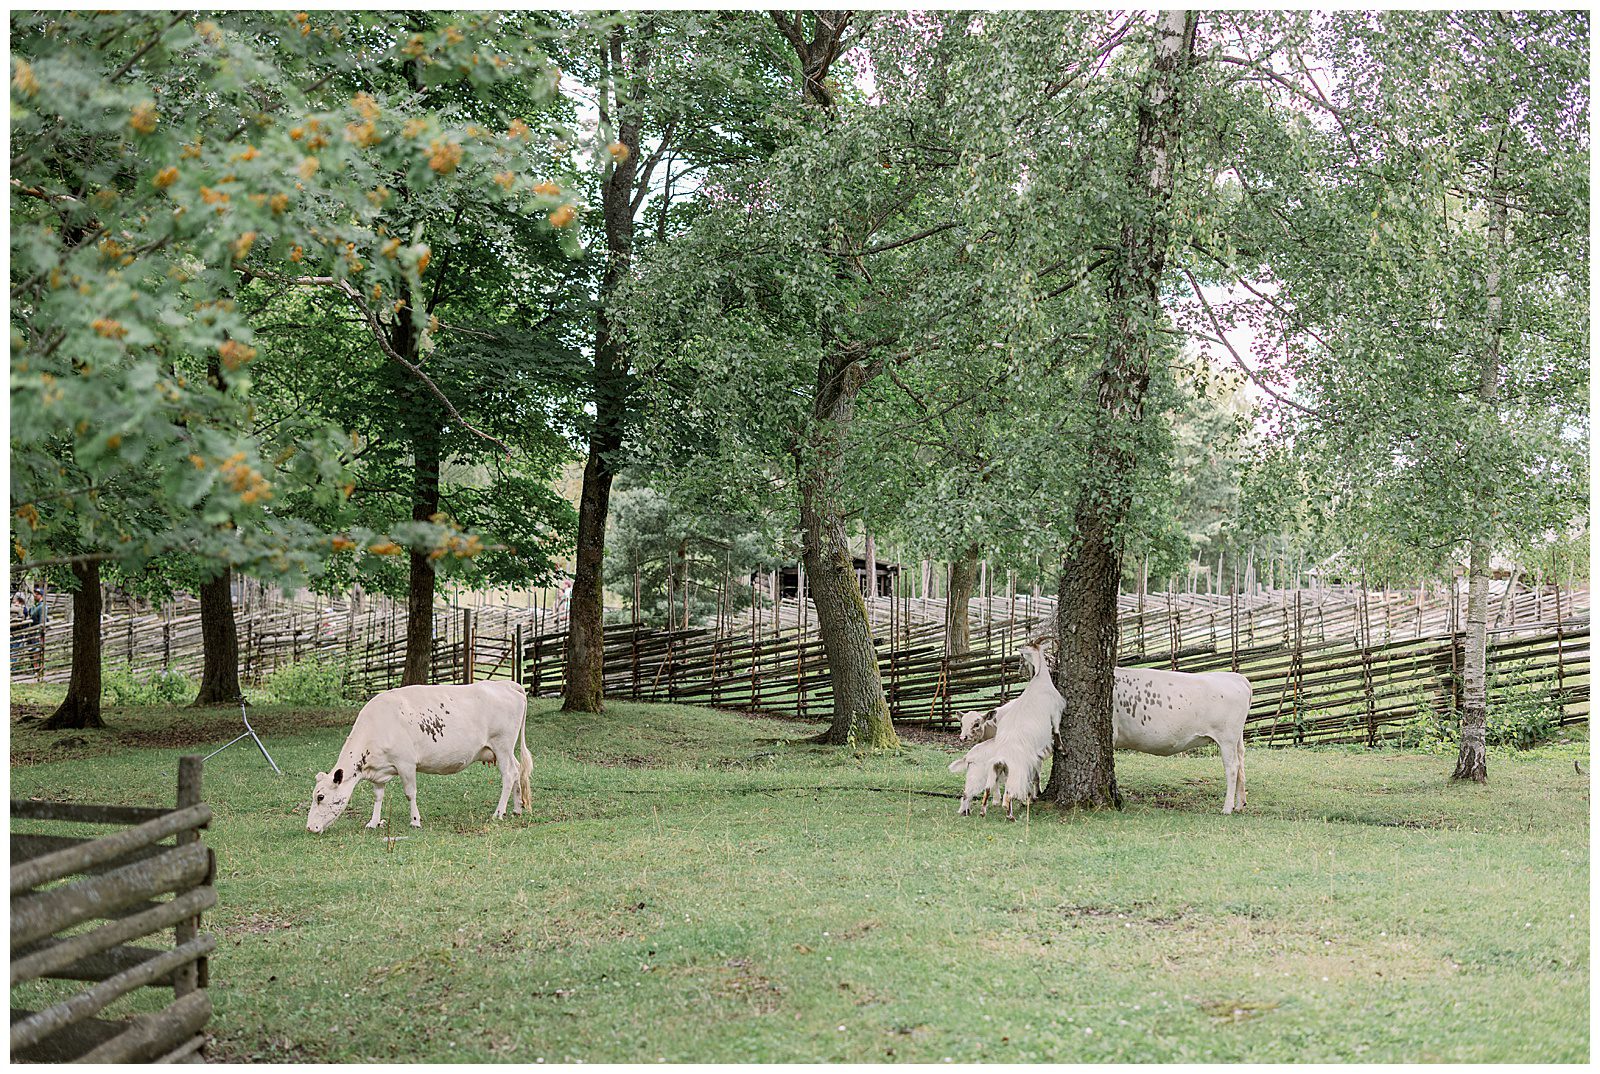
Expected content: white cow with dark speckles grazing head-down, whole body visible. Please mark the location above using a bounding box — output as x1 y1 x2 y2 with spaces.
306 682 533 832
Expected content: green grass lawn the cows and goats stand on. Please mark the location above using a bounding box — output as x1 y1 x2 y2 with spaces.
11 701 1589 1063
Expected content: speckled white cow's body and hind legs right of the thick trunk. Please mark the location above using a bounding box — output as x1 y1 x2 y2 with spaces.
1110 667 1250 813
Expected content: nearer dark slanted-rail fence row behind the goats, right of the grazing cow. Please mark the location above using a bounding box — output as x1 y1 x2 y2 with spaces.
520 624 1589 744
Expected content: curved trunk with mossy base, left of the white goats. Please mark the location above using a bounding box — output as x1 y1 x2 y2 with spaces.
797 354 899 749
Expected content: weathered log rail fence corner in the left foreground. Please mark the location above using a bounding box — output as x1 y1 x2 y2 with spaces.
11 757 216 1063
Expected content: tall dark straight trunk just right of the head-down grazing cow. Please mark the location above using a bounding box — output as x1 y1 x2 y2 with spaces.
562 27 640 712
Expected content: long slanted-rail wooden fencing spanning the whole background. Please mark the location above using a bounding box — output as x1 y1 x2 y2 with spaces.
13 581 1589 744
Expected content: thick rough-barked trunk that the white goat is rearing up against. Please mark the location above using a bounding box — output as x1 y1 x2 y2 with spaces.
1046 11 1195 808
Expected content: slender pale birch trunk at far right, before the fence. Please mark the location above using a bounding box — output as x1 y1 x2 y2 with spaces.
1451 131 1506 783
